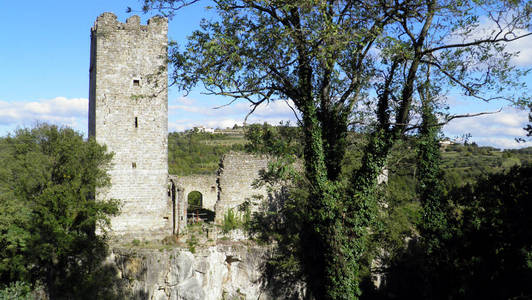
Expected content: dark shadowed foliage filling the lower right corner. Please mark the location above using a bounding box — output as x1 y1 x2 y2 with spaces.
378 165 532 299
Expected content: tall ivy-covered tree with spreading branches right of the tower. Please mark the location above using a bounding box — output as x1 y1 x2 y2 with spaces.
144 0 531 299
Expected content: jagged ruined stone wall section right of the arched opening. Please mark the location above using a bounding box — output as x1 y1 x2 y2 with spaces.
215 152 270 223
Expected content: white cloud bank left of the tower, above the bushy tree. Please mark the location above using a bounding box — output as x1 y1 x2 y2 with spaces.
0 97 88 133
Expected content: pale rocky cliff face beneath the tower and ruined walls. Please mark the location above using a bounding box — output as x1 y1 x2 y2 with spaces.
109 243 272 300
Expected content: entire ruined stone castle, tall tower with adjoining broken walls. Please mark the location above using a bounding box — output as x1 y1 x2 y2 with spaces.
89 13 286 239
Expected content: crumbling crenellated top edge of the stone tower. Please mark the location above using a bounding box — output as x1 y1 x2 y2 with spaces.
91 12 168 31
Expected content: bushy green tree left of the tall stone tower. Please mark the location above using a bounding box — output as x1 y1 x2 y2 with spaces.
0 125 118 299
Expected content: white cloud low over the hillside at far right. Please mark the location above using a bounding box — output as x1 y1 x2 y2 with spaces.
444 108 532 148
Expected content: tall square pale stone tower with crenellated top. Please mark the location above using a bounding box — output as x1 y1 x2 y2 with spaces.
89 13 171 238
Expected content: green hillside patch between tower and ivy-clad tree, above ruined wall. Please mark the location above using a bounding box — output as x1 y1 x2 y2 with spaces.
168 130 244 175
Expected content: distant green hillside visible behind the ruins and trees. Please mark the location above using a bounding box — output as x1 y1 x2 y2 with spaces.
168 127 532 185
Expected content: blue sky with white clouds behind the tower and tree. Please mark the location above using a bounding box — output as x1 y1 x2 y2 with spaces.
0 0 532 148
